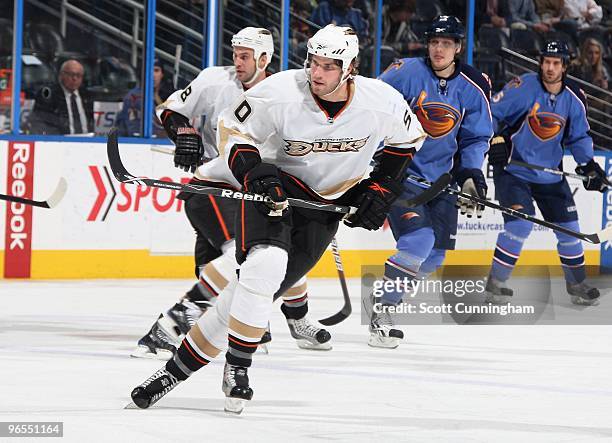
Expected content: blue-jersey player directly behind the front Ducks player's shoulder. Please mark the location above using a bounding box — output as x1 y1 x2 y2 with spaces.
366 16 493 348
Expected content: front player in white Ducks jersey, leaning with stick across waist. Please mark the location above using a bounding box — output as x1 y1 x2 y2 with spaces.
131 25 425 413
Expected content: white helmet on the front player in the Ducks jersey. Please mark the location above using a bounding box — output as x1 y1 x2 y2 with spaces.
307 24 359 81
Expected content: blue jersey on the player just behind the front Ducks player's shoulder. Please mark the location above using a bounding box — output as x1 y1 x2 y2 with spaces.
379 58 493 181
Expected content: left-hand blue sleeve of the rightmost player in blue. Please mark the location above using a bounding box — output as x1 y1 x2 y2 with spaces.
491 77 531 133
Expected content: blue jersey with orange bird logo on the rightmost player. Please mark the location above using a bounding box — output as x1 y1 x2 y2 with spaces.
491 73 593 183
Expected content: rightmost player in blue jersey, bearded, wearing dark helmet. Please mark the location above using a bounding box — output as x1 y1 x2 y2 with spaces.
486 40 607 305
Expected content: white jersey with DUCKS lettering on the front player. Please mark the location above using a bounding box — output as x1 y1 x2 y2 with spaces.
196 69 426 199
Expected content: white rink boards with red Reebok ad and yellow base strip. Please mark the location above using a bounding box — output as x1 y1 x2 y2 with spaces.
0 140 612 279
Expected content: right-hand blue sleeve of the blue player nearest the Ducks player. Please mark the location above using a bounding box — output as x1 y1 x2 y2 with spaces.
457 71 493 169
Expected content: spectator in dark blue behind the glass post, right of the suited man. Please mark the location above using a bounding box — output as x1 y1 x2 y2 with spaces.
115 58 174 137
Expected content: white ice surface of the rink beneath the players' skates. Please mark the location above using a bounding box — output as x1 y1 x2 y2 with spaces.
0 280 612 443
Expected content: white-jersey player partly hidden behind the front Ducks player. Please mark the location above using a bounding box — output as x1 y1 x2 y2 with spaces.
131 27 331 360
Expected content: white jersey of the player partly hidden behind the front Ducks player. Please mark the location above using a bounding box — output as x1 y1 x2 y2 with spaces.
155 66 244 157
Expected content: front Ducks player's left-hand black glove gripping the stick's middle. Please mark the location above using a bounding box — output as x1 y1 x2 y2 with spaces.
244 163 290 220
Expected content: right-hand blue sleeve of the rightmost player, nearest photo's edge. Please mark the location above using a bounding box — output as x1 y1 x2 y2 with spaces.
561 85 593 164
